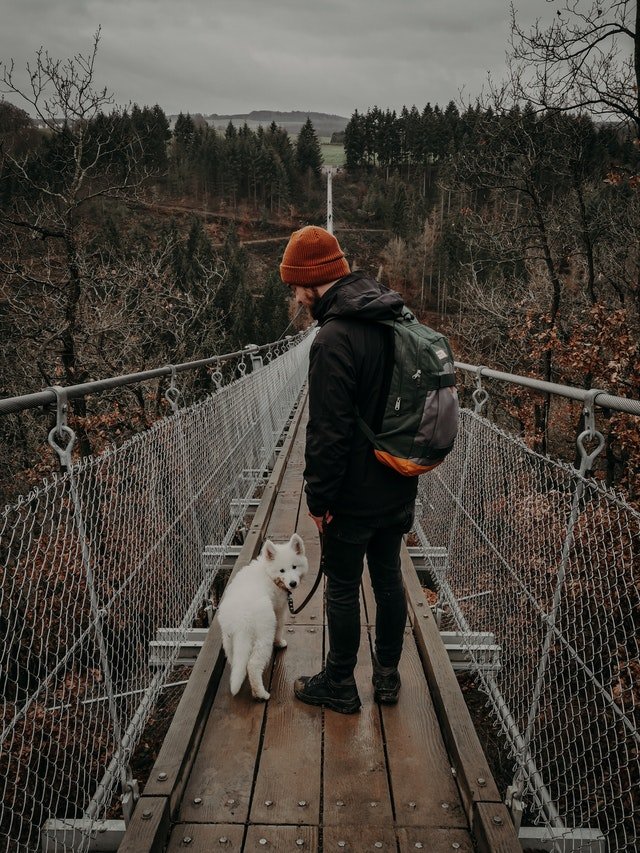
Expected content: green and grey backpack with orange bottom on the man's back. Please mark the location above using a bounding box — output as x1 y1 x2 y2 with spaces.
357 307 459 477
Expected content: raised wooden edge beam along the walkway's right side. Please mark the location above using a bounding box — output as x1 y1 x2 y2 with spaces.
401 546 501 822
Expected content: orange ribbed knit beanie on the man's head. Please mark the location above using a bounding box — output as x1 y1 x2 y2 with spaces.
280 225 350 287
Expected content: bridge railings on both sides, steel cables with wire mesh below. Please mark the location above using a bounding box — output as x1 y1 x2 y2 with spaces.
0 342 640 853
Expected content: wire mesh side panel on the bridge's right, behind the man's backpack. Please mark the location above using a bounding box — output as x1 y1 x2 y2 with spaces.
418 410 640 853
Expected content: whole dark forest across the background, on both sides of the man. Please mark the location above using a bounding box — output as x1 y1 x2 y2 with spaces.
0 6 640 510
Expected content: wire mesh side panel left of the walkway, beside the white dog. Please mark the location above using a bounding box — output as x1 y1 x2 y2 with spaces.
0 335 311 853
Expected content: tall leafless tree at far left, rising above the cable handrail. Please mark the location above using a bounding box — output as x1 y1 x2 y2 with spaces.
0 31 160 392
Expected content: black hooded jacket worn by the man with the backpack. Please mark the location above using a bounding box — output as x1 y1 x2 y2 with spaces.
304 272 417 519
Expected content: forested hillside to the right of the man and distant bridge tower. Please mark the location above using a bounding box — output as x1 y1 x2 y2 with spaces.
344 102 640 499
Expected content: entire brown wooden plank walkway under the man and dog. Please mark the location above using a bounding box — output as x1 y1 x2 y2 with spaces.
120 398 521 853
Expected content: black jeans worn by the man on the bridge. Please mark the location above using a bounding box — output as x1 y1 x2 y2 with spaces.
322 503 414 681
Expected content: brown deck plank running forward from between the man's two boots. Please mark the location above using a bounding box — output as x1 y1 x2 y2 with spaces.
323 628 393 827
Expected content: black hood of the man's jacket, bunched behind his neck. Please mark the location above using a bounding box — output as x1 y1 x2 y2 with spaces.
311 272 404 326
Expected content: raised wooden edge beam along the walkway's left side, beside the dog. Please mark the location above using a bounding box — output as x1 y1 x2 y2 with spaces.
123 392 306 850
